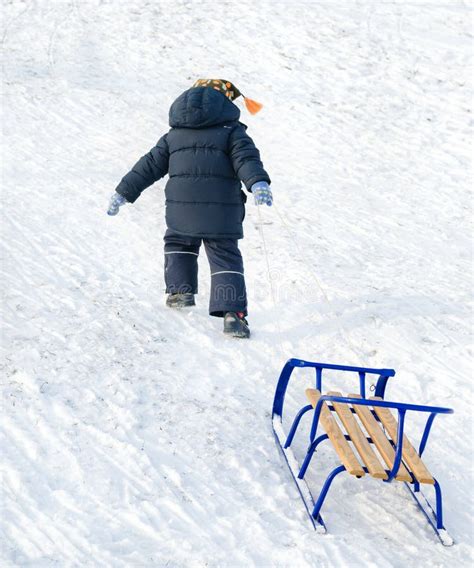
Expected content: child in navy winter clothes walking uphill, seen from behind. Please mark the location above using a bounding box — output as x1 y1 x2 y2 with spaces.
108 79 273 337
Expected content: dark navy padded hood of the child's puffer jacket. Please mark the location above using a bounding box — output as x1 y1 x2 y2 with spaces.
169 87 240 128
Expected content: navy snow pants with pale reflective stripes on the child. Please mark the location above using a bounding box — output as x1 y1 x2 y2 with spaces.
164 229 247 317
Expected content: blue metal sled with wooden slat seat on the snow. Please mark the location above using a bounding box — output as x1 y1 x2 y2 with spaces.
272 359 454 546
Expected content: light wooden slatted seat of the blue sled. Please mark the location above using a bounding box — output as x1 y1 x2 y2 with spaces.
306 389 435 485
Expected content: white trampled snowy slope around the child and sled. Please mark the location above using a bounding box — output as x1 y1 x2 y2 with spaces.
0 0 473 568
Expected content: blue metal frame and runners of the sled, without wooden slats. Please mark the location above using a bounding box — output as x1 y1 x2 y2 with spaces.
272 359 454 546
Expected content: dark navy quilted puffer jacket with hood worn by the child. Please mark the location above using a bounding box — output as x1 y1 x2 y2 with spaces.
116 87 270 239
